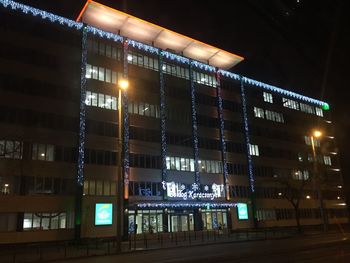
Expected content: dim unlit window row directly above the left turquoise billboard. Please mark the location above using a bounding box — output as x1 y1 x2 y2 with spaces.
83 179 117 196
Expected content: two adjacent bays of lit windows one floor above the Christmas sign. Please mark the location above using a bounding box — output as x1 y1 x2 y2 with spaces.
166 156 222 173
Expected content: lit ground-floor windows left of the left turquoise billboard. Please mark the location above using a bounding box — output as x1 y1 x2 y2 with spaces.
23 212 74 230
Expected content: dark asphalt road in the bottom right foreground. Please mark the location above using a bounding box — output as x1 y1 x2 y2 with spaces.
58 234 350 263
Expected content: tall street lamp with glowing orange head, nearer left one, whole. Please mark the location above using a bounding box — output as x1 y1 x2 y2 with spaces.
116 79 129 252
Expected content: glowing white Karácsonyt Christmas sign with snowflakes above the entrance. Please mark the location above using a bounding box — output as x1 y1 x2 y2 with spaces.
162 181 225 200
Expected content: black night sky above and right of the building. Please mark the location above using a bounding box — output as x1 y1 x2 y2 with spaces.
12 0 350 194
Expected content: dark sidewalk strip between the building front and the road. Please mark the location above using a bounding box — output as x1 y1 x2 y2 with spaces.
0 229 339 263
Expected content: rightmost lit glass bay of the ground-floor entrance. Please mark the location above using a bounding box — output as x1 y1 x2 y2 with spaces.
202 209 227 230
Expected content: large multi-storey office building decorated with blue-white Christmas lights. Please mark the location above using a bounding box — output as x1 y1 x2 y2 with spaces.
0 0 348 243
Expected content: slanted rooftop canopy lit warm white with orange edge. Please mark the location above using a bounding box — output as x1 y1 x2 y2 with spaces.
77 0 244 69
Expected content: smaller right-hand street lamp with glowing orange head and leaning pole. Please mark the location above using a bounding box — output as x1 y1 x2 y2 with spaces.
311 130 328 232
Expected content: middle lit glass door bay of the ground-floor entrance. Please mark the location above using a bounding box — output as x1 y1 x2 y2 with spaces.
168 211 194 232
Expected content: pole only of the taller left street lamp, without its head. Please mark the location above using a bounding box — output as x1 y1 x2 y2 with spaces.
116 88 123 253
